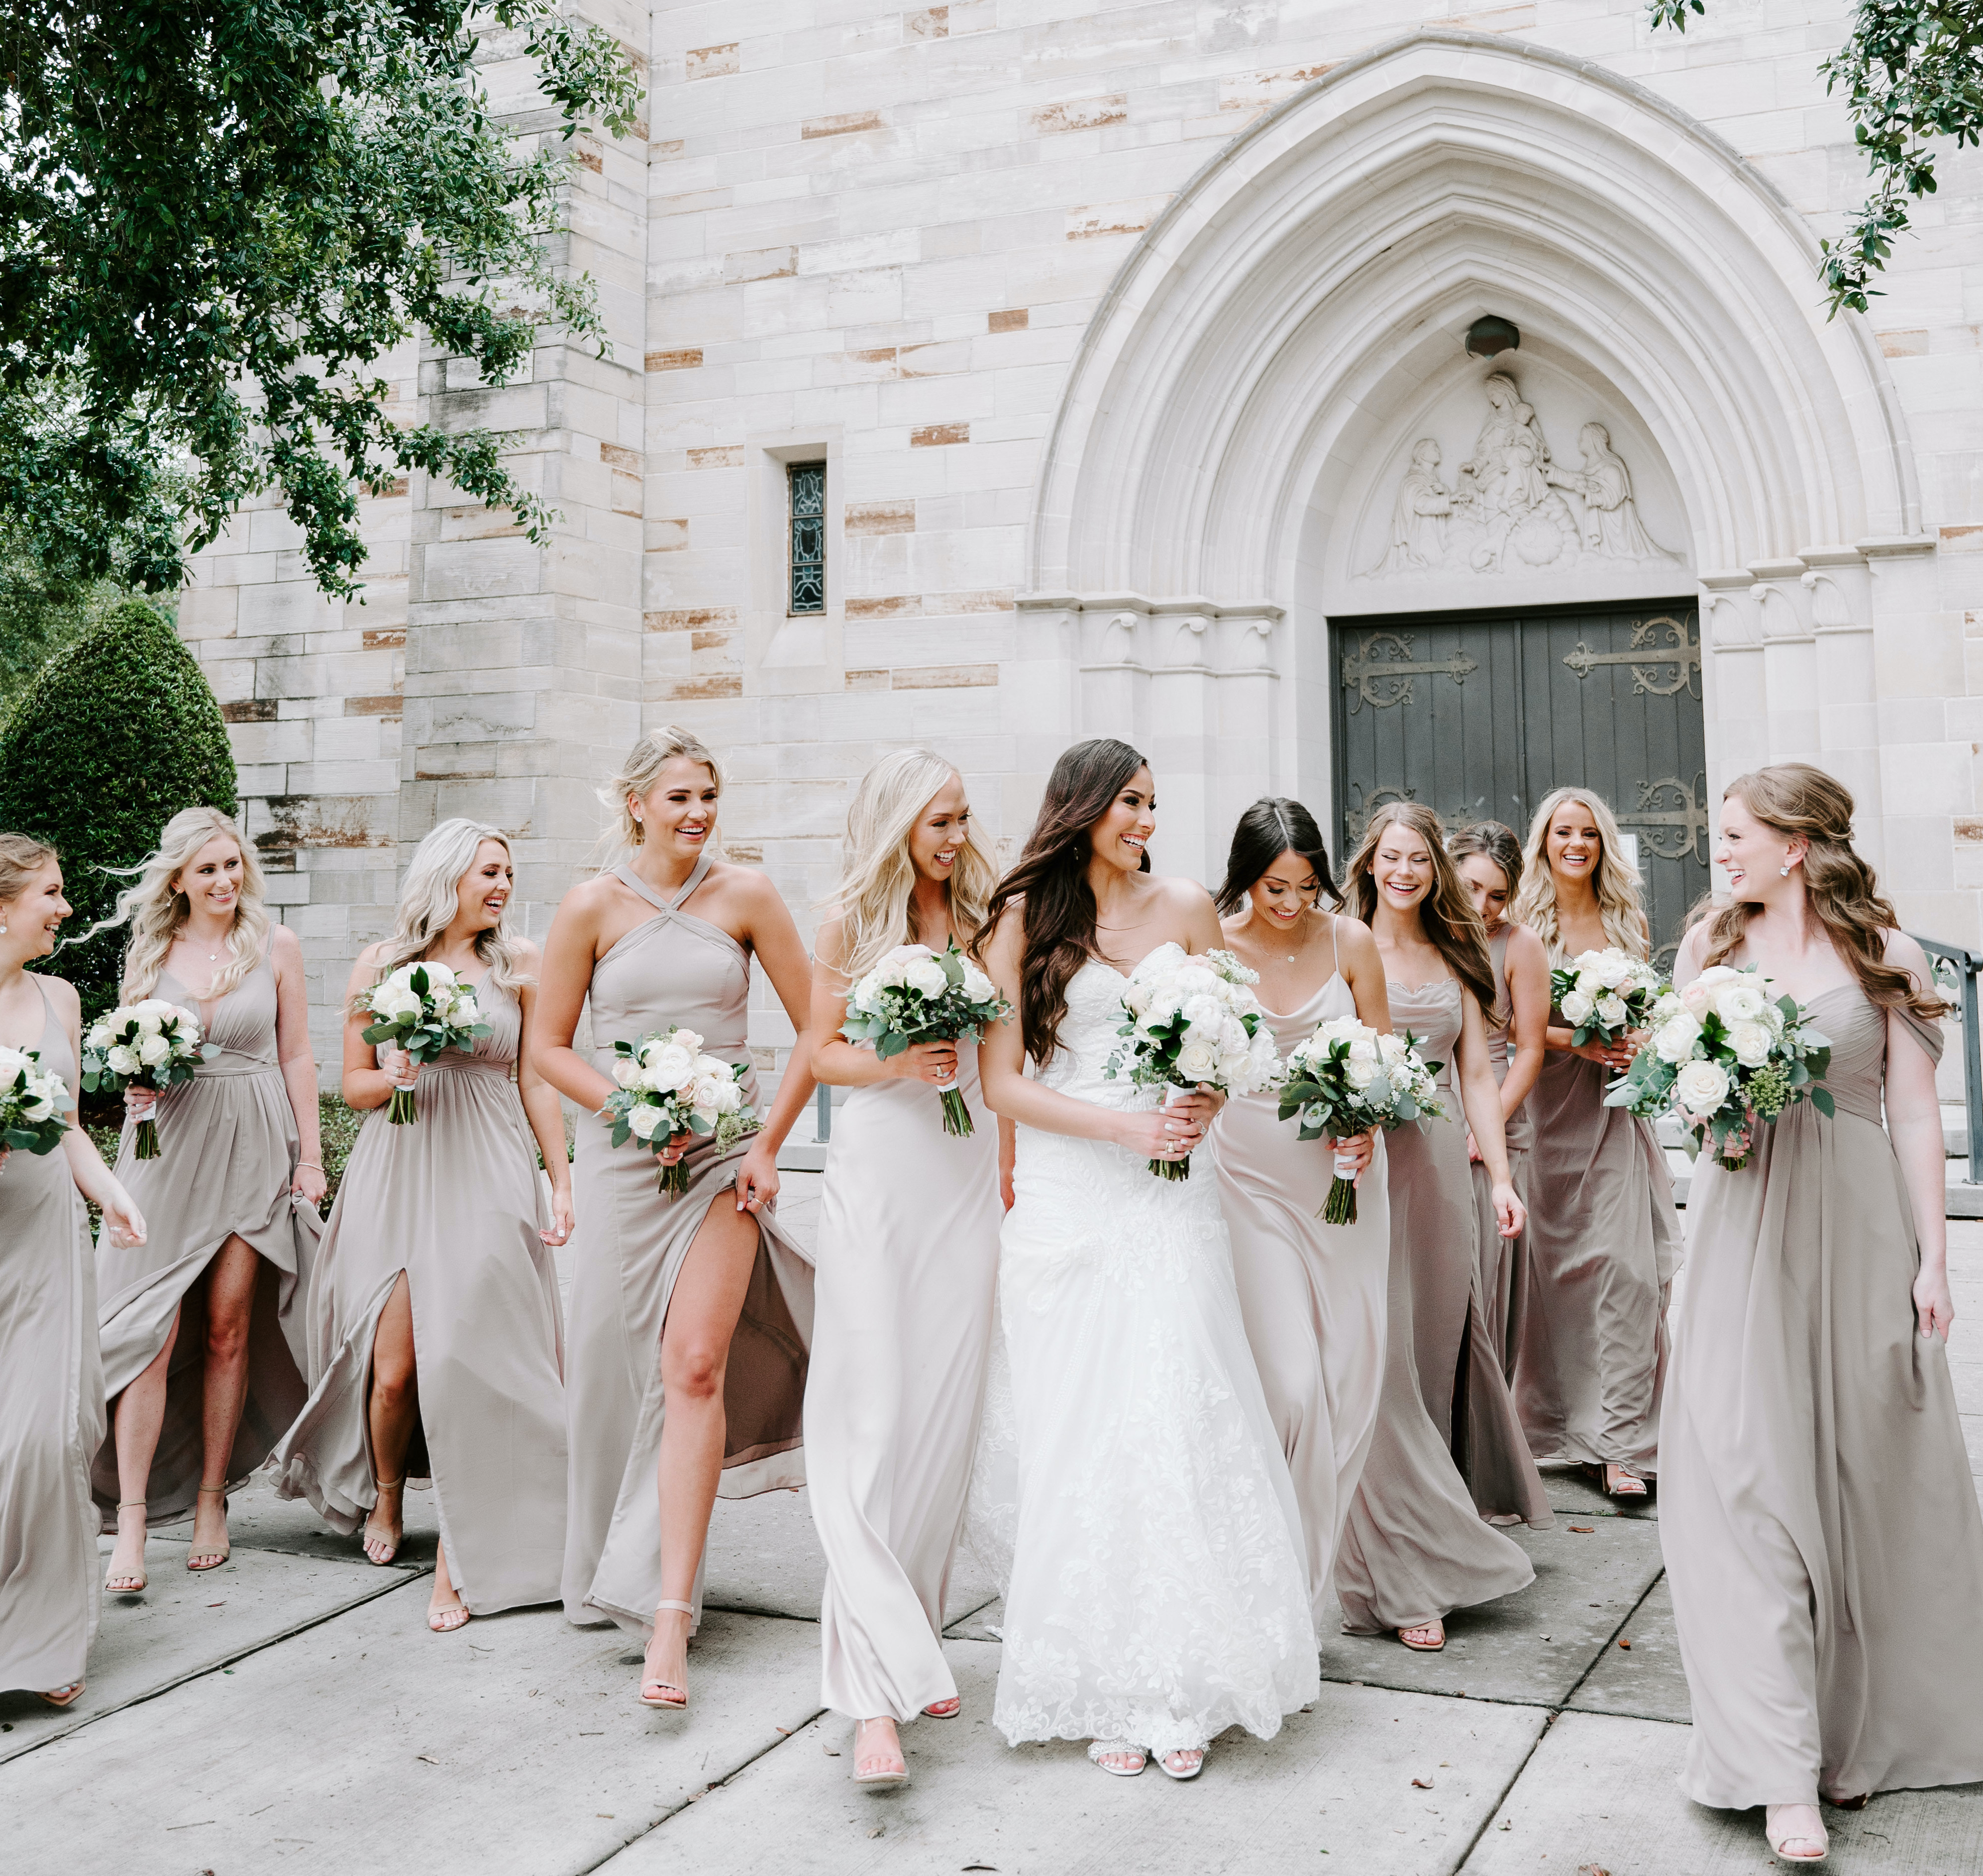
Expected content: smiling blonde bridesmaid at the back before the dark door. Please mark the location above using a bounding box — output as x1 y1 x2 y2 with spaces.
1515 787 1680 1499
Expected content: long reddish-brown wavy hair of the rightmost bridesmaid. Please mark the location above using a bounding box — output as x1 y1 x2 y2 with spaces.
1694 762 1949 1023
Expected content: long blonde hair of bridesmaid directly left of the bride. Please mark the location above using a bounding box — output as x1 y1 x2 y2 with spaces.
821 750 997 978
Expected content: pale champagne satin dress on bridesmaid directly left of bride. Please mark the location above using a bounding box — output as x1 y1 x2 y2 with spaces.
805 1041 1003 1719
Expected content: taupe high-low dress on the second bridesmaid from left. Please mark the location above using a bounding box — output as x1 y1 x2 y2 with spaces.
93 934 323 1531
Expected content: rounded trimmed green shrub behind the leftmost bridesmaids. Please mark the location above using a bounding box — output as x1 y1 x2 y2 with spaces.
0 601 238 1023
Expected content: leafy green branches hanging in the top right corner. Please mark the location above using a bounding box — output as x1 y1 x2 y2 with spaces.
1650 0 1983 316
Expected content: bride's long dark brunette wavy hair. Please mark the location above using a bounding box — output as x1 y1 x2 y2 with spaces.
972 736 1150 1067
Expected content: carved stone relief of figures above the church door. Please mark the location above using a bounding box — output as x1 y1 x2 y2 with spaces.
1361 371 1680 579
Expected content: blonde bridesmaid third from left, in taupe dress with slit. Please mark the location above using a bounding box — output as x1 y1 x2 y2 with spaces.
276 821 571 1634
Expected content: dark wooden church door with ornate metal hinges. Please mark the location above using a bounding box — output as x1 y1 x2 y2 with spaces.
1330 599 1707 962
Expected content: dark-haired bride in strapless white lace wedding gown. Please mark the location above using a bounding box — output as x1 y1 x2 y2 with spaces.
980 740 1319 1779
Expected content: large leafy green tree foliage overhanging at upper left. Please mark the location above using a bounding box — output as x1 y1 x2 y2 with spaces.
0 0 639 595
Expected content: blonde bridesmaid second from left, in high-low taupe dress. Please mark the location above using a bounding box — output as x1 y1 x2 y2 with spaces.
93 807 323 1595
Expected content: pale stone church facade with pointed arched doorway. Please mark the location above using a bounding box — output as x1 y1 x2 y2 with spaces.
180 0 1983 1055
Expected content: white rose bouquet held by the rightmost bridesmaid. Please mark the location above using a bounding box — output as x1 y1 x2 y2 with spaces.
1604 964 1834 1172
